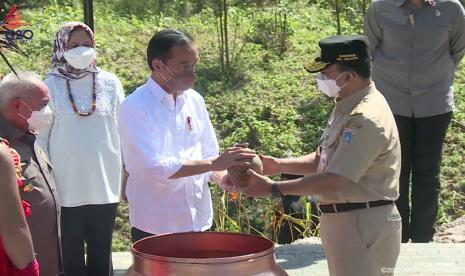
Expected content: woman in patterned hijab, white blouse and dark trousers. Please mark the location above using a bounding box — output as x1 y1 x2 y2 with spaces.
41 22 124 276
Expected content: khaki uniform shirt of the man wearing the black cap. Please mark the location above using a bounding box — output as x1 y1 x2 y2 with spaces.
317 84 401 204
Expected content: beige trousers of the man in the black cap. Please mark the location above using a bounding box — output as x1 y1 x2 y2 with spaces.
320 204 402 276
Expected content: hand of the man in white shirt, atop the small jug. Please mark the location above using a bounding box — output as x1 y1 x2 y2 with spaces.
212 147 256 171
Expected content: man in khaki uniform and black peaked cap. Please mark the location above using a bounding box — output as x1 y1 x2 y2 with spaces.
241 36 401 276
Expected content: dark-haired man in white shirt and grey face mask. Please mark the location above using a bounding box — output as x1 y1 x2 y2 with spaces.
118 29 255 242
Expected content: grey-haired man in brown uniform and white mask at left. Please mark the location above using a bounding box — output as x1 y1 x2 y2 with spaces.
0 72 61 276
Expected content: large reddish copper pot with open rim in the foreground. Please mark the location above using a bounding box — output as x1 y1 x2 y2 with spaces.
127 232 288 276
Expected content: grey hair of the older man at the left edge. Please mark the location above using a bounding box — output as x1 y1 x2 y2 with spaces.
0 71 42 110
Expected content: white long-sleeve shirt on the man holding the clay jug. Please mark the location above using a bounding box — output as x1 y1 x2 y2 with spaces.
118 77 219 234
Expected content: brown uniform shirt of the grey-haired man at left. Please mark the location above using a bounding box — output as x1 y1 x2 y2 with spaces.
0 116 61 276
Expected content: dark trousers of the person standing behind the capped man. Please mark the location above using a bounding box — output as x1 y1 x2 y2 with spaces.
395 112 452 242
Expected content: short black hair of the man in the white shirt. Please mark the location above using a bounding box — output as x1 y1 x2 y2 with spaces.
147 29 194 70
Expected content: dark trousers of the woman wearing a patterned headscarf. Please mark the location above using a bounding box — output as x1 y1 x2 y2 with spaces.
61 203 118 276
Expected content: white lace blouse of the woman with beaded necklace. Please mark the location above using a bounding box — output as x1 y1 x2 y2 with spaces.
39 70 124 207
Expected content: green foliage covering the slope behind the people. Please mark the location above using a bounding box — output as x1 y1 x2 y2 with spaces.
0 0 465 250
